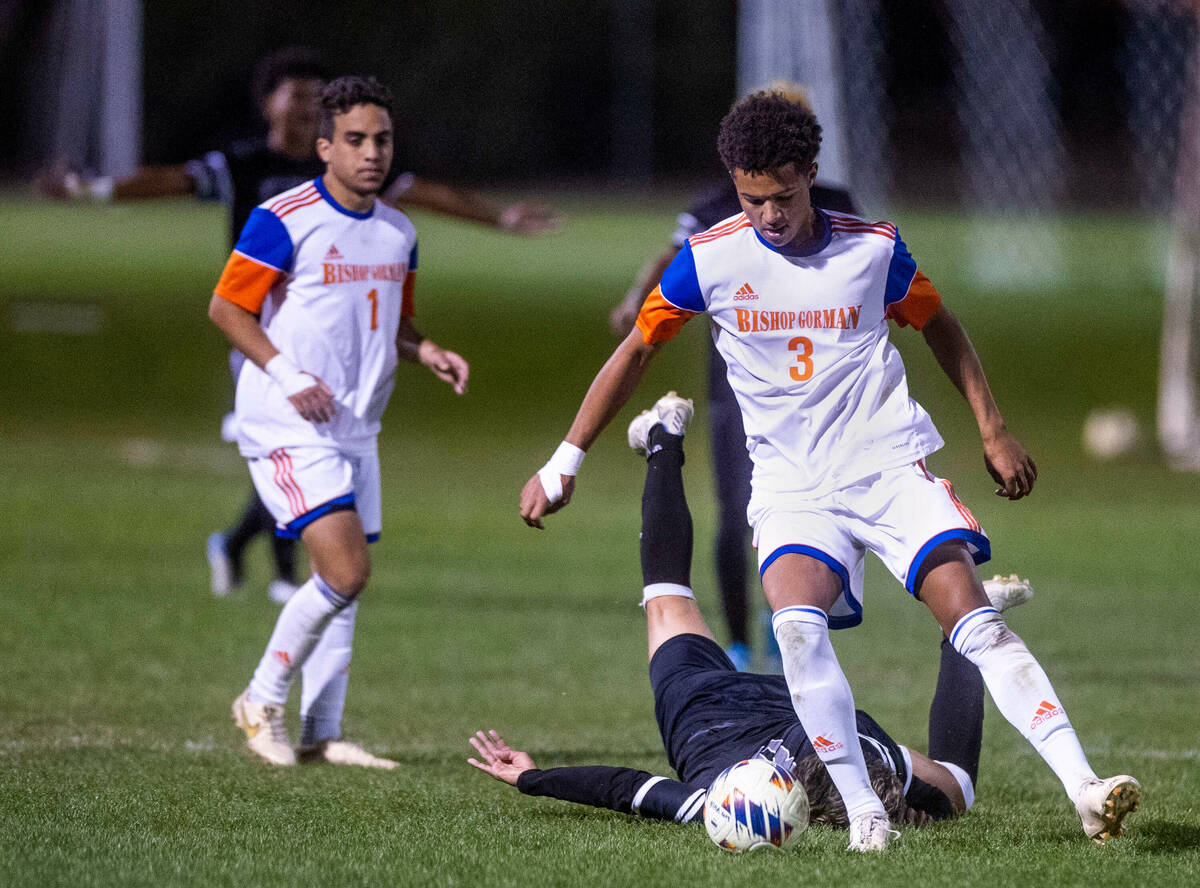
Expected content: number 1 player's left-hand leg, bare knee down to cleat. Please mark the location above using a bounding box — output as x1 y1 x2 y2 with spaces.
233 510 371 764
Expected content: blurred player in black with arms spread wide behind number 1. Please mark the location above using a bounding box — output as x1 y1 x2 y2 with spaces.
37 47 559 604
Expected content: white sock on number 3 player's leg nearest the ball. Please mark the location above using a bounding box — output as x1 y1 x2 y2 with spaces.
770 607 887 822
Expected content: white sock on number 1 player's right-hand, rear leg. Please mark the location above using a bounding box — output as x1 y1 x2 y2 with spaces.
300 601 359 749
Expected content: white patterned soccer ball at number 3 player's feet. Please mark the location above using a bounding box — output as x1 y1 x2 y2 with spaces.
704 758 809 853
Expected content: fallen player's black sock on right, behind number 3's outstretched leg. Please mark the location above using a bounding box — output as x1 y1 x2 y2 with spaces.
929 638 984 784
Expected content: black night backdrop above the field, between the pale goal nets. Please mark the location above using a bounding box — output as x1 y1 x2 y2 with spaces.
0 0 1180 206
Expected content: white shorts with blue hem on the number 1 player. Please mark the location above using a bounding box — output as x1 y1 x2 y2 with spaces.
247 446 383 542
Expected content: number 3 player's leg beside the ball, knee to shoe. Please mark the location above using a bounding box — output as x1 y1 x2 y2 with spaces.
762 552 899 851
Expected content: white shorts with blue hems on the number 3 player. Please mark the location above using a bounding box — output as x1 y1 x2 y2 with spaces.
750 461 991 629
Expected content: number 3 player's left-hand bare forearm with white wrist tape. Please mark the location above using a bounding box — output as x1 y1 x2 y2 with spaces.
521 329 661 529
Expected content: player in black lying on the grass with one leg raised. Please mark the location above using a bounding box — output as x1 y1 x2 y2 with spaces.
468 392 1051 828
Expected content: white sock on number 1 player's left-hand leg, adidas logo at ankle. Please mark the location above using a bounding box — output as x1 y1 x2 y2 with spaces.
250 574 353 703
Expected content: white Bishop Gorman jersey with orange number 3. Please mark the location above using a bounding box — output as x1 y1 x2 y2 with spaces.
637 210 942 504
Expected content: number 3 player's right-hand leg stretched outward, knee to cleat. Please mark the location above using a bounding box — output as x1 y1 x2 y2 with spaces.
917 541 1139 842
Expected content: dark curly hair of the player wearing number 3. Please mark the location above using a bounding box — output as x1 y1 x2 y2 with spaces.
716 91 821 173
